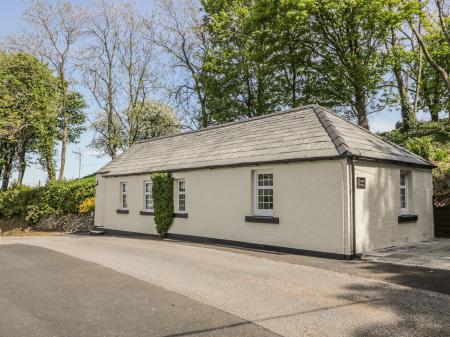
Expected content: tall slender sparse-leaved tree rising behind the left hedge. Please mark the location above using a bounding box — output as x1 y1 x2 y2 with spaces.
8 0 85 180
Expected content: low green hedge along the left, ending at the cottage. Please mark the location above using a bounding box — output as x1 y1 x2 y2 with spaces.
0 177 95 224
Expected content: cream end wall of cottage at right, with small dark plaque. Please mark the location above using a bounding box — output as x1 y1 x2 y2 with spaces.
355 161 434 253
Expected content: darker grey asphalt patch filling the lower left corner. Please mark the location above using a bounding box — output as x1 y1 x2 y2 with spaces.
0 245 277 337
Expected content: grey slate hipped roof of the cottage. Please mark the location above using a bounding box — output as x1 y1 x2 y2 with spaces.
97 105 432 176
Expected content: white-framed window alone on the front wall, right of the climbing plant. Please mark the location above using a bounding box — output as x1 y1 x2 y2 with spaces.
254 171 273 216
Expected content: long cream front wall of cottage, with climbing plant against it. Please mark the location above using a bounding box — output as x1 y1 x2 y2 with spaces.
96 160 349 254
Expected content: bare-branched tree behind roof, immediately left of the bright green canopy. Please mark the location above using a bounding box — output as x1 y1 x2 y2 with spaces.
155 0 211 127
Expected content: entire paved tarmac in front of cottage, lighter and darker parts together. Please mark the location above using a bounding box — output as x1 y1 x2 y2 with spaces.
0 236 450 337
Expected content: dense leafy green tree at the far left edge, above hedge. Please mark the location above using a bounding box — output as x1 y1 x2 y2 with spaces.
0 53 58 190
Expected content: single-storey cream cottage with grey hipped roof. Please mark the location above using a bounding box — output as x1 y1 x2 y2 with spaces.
95 105 433 258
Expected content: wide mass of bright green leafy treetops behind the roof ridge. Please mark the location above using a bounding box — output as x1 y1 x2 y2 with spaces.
202 0 399 126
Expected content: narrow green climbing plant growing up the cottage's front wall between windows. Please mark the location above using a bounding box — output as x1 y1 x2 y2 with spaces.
152 173 174 237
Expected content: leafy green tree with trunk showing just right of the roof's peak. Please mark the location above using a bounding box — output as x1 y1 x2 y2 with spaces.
308 0 392 129
